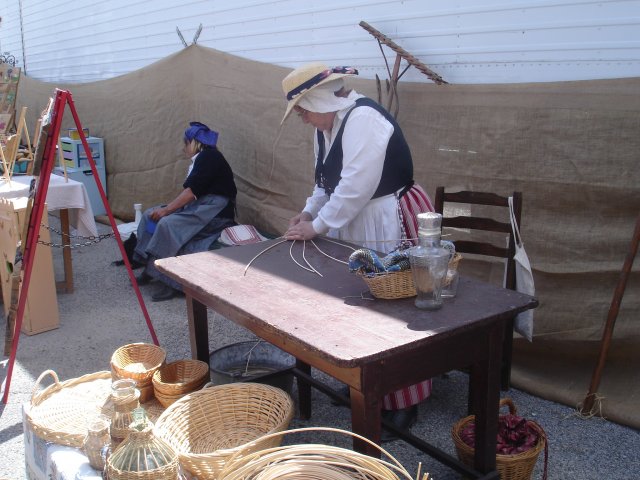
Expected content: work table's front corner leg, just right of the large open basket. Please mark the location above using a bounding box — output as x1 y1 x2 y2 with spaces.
351 388 382 458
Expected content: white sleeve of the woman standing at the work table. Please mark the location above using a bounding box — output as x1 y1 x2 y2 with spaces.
313 107 393 234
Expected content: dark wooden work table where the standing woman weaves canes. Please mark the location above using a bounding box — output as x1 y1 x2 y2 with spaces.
156 239 537 478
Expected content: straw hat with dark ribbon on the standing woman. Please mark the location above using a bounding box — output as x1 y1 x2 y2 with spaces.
280 63 358 124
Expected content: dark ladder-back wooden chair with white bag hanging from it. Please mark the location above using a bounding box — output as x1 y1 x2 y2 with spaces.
434 187 522 390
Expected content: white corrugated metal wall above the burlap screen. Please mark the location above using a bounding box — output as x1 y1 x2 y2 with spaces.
0 0 640 83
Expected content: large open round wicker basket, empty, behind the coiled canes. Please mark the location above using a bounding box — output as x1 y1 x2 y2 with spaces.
155 383 294 480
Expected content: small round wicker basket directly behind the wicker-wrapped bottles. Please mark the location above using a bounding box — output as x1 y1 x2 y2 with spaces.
111 343 167 388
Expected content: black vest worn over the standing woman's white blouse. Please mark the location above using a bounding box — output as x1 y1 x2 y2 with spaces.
316 97 413 198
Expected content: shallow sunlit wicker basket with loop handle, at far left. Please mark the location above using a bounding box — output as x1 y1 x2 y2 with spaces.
25 370 111 448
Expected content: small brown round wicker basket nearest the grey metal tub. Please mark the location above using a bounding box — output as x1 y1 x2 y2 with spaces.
153 359 209 396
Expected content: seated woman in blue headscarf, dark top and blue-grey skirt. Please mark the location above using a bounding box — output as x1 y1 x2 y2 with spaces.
134 122 237 302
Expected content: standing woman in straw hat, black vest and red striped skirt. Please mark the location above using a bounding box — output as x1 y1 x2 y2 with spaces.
282 63 433 440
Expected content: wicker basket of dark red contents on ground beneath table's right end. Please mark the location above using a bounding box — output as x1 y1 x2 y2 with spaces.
451 398 547 480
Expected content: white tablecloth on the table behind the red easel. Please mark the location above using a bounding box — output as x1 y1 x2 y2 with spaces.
0 174 98 236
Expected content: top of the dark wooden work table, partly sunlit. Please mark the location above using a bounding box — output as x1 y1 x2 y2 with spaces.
156 238 537 367
